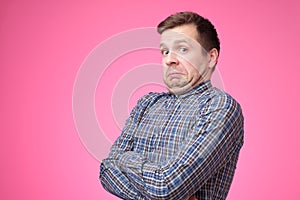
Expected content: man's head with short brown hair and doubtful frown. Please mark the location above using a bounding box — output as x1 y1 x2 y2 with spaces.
157 12 220 95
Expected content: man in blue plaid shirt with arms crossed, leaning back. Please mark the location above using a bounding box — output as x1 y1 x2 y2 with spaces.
100 12 243 200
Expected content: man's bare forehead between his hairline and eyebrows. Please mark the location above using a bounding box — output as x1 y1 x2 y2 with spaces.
160 24 198 45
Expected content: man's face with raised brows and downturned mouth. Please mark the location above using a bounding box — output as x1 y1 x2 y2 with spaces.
160 24 218 95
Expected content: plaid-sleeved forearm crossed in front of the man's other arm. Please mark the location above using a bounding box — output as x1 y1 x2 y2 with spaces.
119 138 230 199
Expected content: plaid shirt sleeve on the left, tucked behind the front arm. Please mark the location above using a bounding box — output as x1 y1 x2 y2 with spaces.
99 93 161 200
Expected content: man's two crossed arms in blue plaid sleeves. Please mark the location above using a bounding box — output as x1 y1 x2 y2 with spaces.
100 94 243 199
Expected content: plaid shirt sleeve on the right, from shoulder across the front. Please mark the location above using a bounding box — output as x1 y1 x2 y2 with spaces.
115 96 243 199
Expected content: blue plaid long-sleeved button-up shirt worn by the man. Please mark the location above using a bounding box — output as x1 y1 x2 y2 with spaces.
100 81 244 200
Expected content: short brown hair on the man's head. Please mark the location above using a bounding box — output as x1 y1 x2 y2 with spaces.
157 12 220 52
